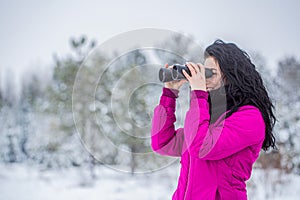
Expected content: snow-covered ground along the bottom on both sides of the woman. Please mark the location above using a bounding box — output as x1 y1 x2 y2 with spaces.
0 164 300 200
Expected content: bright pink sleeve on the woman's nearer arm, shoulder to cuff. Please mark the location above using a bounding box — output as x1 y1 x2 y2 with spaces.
184 90 265 160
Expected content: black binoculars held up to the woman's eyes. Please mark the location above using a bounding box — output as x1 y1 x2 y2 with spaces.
158 64 214 82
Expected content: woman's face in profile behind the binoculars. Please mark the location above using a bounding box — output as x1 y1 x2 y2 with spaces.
204 56 222 91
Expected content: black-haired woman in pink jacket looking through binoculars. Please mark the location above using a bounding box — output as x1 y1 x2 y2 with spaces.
151 40 276 200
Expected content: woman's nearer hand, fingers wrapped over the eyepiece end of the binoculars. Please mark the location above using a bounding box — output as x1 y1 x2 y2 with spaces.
183 62 206 91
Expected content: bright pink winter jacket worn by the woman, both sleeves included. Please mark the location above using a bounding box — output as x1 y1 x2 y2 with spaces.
151 88 265 200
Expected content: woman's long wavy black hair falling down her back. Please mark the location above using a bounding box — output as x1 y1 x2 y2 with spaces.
204 40 276 150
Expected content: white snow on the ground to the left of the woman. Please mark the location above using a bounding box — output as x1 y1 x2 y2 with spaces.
0 165 177 200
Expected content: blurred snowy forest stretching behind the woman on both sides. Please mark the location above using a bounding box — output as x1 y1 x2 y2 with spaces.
0 35 300 199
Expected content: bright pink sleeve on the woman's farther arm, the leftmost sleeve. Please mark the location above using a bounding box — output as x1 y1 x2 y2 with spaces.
151 88 184 156
